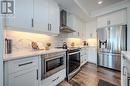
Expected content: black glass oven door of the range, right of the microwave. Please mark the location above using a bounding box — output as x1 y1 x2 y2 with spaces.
68 51 80 74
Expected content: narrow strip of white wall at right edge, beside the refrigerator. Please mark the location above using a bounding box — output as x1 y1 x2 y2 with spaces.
127 1 130 51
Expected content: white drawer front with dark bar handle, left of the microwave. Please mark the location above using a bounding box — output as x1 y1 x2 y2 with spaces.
5 56 38 74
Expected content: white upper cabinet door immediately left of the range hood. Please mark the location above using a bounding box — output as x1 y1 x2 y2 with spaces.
48 0 60 34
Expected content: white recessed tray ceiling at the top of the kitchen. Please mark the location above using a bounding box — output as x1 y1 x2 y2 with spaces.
56 0 128 21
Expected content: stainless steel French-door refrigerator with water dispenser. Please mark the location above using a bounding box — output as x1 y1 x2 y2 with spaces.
97 25 127 70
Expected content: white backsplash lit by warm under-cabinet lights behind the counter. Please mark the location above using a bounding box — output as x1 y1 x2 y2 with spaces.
5 30 81 52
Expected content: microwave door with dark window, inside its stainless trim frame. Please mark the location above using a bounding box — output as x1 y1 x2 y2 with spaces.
44 55 65 78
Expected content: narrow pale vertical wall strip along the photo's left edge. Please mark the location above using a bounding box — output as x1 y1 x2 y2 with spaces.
0 15 3 86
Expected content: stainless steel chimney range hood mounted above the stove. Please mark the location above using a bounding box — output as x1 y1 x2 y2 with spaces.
60 10 75 33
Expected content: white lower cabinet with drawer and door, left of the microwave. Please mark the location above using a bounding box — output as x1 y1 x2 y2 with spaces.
4 56 39 86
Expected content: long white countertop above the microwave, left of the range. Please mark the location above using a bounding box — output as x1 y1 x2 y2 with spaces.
3 49 66 61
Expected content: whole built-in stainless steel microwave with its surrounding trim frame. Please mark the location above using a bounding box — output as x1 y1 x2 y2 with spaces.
41 52 66 80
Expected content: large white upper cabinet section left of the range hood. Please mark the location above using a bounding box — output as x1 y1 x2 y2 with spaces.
6 0 60 34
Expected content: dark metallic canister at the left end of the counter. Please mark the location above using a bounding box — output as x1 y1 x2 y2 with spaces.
5 38 12 54
